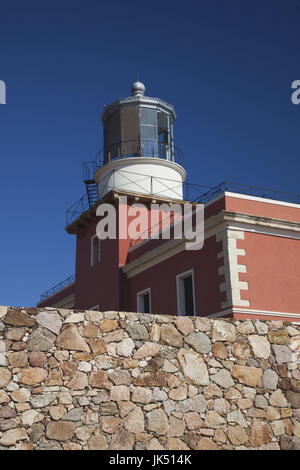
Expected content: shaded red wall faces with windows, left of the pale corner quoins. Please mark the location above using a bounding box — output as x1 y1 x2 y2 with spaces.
75 198 229 316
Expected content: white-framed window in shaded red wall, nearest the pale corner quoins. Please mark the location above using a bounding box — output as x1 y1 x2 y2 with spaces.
176 270 195 316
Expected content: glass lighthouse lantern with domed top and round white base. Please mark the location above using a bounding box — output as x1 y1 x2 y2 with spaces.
94 81 186 200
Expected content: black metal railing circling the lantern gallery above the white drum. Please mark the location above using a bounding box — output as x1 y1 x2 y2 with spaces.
83 139 184 181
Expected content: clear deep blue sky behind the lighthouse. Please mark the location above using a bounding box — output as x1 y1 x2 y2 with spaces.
0 0 300 306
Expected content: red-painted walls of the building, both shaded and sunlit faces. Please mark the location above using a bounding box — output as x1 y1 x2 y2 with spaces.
40 193 300 322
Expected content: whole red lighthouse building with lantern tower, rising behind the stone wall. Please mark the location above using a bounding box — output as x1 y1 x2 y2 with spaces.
38 82 300 321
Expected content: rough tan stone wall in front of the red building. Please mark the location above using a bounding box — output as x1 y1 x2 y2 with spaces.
0 307 300 450
